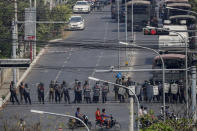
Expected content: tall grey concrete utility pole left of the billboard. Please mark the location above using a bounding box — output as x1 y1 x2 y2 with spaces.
12 0 18 87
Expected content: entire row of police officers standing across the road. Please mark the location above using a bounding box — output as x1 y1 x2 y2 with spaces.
10 76 186 104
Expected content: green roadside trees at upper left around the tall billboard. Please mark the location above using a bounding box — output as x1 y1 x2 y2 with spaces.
0 0 72 58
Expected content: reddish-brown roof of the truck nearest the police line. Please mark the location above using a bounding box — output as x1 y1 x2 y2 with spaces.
154 54 185 60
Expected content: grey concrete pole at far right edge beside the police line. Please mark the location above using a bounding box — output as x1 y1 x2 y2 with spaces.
192 66 196 123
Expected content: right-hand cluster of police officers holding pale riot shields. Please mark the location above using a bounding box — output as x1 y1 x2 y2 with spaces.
114 76 186 103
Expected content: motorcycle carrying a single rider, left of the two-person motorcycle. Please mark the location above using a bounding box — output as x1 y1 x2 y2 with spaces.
68 115 92 129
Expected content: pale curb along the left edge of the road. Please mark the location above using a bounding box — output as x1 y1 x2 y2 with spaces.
0 39 62 110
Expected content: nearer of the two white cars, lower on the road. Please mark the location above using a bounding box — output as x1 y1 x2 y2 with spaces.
68 16 85 30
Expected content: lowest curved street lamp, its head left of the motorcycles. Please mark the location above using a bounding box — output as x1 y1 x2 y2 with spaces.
30 110 90 131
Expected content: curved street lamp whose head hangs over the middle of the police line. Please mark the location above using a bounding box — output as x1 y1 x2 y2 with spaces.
88 77 140 130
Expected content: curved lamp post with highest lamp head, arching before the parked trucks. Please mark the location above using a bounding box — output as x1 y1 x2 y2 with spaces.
120 42 166 121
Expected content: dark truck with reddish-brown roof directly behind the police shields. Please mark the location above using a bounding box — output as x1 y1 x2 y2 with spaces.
152 54 185 83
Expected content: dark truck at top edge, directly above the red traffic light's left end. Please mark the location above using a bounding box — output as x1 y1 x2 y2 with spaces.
127 0 151 31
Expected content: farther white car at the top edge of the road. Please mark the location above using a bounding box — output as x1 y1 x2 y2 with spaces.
73 1 91 13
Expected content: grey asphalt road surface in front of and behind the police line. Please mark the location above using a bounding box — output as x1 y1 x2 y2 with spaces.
0 6 186 131
